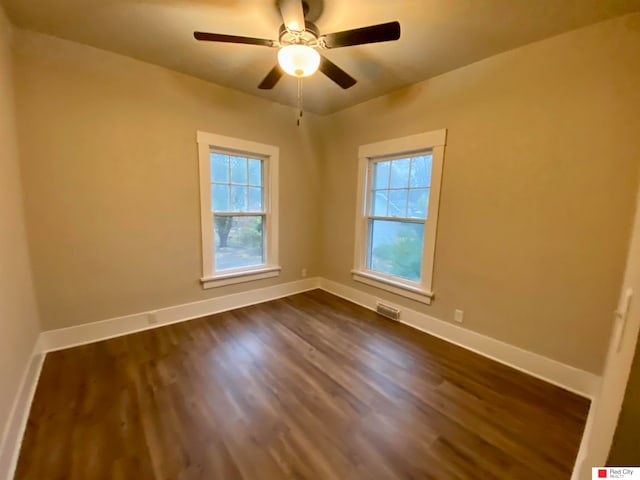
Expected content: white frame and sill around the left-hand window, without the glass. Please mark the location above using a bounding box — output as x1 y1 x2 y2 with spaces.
196 131 282 288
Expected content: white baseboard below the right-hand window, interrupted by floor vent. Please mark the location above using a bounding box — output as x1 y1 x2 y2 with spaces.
320 278 601 399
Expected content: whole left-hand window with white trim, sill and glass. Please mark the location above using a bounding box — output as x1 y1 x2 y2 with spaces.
197 132 280 288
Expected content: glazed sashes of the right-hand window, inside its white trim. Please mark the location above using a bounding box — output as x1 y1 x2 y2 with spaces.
366 150 433 283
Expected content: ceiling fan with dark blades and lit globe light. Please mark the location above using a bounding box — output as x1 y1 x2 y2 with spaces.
193 0 400 90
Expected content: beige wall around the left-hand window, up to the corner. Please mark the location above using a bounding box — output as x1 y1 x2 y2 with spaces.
15 32 320 329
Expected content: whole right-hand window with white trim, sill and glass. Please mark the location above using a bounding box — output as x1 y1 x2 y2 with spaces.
352 130 446 304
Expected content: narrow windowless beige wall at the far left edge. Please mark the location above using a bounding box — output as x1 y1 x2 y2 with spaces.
0 3 39 460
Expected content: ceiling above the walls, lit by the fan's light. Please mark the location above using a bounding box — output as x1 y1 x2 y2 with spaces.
2 0 640 113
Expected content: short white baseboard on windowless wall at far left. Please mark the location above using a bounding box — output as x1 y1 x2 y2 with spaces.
0 338 45 480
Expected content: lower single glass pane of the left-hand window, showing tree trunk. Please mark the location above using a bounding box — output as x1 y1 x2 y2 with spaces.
213 216 264 272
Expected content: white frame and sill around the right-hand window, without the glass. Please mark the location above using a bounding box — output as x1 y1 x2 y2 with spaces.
351 129 447 304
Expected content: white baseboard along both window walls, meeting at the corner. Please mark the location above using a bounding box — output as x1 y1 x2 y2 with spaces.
40 277 601 398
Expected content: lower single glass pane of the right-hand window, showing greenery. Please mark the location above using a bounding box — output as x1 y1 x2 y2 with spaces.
367 220 424 282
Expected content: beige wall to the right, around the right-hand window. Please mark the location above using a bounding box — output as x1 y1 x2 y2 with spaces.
322 15 640 373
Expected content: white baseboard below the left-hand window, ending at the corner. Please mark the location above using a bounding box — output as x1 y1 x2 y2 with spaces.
40 277 320 352
